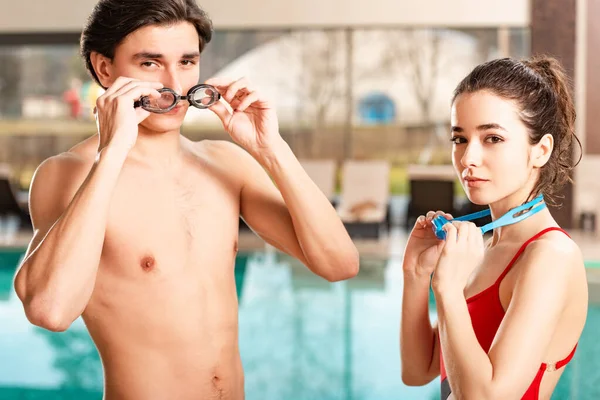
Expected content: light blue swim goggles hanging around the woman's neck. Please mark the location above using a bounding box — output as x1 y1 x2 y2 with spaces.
432 194 546 240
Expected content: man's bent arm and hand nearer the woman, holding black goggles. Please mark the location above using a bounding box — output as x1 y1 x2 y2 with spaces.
206 78 359 281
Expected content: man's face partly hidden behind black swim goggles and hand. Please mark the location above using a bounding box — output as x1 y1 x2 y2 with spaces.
103 22 200 132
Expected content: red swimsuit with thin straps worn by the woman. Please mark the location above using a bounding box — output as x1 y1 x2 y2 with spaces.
440 228 577 400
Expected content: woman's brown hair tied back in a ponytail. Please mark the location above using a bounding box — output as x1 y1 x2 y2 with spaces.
452 56 582 205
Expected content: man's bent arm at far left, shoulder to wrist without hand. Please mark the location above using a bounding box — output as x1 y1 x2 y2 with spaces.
15 147 124 331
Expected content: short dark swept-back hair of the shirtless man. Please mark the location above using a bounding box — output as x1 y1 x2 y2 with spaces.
80 0 213 86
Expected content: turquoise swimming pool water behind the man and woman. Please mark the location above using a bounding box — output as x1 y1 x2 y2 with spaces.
0 251 600 400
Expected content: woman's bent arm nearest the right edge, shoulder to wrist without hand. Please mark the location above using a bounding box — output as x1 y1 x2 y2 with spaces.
434 225 582 399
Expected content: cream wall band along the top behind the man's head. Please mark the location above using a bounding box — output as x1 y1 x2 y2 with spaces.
0 0 530 33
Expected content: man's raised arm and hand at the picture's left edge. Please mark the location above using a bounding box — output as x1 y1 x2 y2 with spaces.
15 77 168 331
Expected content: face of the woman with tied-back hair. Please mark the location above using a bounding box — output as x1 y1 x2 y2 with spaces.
451 91 538 205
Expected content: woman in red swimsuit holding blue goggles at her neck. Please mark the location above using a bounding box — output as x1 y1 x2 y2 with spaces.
400 57 588 400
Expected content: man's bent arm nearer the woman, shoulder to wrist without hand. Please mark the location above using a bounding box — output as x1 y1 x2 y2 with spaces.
221 139 359 281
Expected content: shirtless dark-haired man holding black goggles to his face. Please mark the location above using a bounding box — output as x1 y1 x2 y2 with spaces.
15 0 358 400
